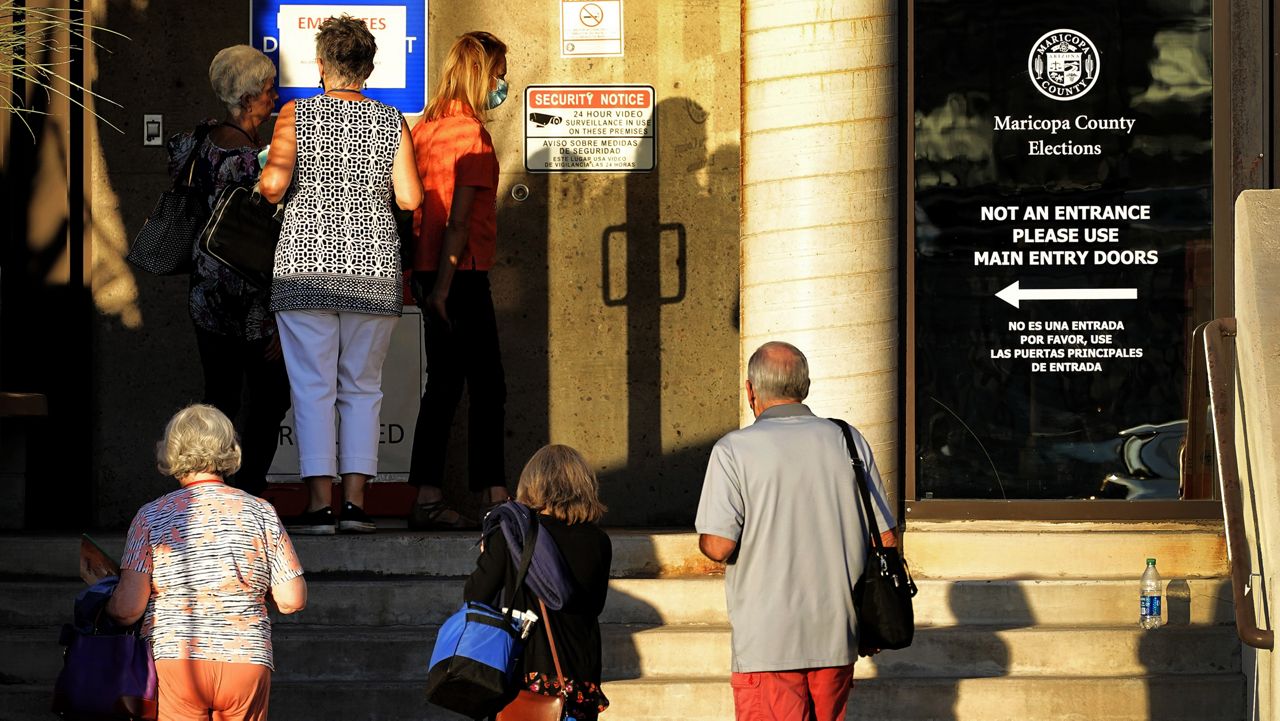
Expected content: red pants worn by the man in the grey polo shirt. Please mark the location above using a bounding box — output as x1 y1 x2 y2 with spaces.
730 663 854 721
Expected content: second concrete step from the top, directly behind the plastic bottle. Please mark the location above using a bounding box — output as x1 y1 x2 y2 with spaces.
0 576 1234 626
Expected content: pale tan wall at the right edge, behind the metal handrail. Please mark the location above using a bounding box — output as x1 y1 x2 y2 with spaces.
1231 191 1280 718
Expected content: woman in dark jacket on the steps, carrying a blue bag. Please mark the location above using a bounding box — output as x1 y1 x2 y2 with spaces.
463 446 613 721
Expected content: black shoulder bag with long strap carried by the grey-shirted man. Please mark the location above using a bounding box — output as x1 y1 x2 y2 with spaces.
827 419 915 656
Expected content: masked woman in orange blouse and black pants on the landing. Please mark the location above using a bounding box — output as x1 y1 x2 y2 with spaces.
410 31 509 530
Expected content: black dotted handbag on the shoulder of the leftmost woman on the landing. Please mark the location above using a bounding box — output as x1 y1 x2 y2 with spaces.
124 126 209 275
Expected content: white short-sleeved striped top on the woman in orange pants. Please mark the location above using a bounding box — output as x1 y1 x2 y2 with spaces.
120 482 302 668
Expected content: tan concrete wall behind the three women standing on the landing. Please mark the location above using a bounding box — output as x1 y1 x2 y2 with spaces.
93 0 741 525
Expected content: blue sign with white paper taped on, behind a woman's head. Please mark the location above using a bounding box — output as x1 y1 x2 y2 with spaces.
250 0 428 115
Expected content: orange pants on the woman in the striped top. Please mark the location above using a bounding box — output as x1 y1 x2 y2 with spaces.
156 658 271 721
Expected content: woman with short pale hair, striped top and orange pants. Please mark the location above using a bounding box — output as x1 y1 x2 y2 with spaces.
106 405 307 721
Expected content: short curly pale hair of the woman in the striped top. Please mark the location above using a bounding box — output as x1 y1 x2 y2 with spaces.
156 403 241 478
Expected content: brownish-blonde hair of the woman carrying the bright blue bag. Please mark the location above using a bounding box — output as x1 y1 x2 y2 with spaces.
516 444 608 524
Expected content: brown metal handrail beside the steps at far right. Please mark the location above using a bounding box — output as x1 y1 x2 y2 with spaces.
1202 318 1275 651
